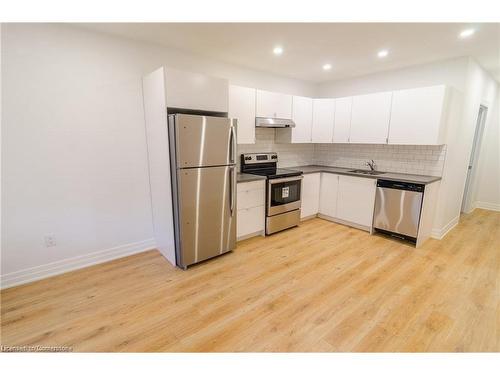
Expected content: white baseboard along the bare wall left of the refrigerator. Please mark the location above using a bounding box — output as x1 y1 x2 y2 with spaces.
0 238 155 289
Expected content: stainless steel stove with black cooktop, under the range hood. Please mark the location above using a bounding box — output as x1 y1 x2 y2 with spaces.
241 152 303 235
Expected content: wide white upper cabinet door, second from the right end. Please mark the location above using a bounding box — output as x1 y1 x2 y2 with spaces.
349 92 392 144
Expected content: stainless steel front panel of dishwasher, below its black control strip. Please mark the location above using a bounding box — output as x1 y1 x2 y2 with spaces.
373 187 423 238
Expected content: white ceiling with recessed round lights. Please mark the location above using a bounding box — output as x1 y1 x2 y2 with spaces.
81 23 500 82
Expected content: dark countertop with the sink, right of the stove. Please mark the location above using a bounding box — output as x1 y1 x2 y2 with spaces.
287 165 441 185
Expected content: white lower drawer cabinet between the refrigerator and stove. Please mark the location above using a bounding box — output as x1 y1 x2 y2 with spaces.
236 180 266 239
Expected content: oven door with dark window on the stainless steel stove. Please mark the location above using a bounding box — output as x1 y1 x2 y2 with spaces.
267 176 303 216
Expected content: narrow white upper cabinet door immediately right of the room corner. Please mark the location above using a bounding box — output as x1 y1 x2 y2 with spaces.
311 99 335 143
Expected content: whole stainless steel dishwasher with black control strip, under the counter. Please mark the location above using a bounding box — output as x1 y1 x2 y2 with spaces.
373 180 425 243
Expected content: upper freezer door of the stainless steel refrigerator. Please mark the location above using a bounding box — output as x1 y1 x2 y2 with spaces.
169 114 236 168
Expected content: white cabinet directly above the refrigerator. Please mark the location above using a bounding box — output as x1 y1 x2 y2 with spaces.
165 68 229 112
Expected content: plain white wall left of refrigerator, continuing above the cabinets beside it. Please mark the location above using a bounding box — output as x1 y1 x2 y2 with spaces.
1 24 315 287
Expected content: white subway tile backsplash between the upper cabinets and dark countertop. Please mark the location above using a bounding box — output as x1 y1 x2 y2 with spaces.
238 128 446 176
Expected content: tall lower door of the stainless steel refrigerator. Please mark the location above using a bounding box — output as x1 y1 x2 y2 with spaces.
177 166 236 268
